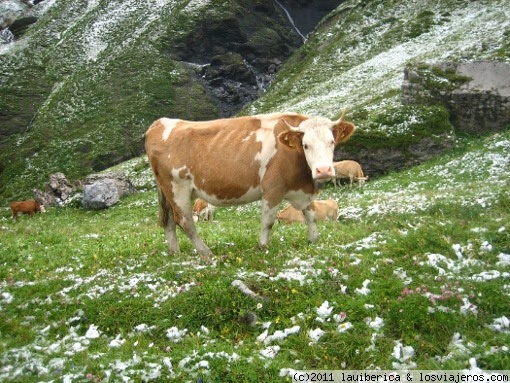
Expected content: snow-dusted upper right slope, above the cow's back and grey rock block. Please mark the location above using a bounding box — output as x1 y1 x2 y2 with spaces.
247 0 510 117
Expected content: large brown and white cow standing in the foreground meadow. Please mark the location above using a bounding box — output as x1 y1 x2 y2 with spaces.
145 113 355 255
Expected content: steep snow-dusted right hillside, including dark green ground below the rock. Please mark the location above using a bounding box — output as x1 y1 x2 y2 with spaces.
244 0 510 175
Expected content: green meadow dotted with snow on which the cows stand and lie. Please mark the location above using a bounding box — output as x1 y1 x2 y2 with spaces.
0 132 510 383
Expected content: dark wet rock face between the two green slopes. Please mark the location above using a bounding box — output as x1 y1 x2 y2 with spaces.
169 0 340 117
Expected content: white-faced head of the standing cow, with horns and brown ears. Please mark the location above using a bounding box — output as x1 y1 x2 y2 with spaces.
278 112 355 181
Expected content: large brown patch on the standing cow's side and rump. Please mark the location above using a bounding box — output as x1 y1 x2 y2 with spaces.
146 117 262 201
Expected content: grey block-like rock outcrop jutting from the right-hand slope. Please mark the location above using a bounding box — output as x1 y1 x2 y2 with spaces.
402 61 510 134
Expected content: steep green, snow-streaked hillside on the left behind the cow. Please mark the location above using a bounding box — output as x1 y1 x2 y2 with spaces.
0 0 300 204
